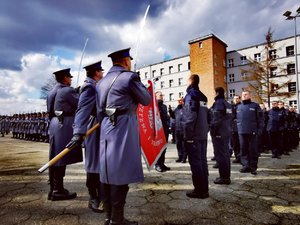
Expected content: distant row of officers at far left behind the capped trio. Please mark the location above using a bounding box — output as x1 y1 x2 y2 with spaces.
0 112 50 143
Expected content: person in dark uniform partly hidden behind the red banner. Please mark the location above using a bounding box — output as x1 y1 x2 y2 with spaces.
155 91 170 172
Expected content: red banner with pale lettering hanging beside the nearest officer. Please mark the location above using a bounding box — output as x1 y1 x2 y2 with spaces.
137 81 167 170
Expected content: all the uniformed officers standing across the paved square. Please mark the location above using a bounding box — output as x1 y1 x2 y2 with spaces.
1 45 300 225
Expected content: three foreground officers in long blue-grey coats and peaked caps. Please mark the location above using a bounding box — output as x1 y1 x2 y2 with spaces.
47 48 151 225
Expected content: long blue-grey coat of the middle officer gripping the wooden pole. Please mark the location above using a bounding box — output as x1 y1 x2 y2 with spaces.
73 77 100 173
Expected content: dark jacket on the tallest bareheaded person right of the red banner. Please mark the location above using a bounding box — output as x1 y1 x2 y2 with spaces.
183 86 209 140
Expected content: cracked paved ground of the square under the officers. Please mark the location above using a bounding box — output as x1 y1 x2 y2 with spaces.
0 136 300 225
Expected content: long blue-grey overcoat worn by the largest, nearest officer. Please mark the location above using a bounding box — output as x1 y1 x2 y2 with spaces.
96 66 151 185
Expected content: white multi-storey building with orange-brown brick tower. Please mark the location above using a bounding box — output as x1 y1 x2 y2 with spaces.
138 34 299 108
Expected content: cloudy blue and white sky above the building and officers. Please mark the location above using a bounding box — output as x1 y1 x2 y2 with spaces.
0 0 300 115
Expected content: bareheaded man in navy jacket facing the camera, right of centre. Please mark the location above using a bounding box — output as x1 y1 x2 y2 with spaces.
237 90 263 175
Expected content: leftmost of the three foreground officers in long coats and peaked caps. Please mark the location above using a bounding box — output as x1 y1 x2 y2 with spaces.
47 69 82 201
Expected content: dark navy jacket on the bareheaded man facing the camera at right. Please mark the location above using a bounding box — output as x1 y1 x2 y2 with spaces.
237 100 264 134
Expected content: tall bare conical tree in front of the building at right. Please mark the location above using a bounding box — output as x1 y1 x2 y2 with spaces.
242 28 294 108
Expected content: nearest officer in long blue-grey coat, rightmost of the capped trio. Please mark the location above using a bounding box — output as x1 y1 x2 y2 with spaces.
96 48 151 225
